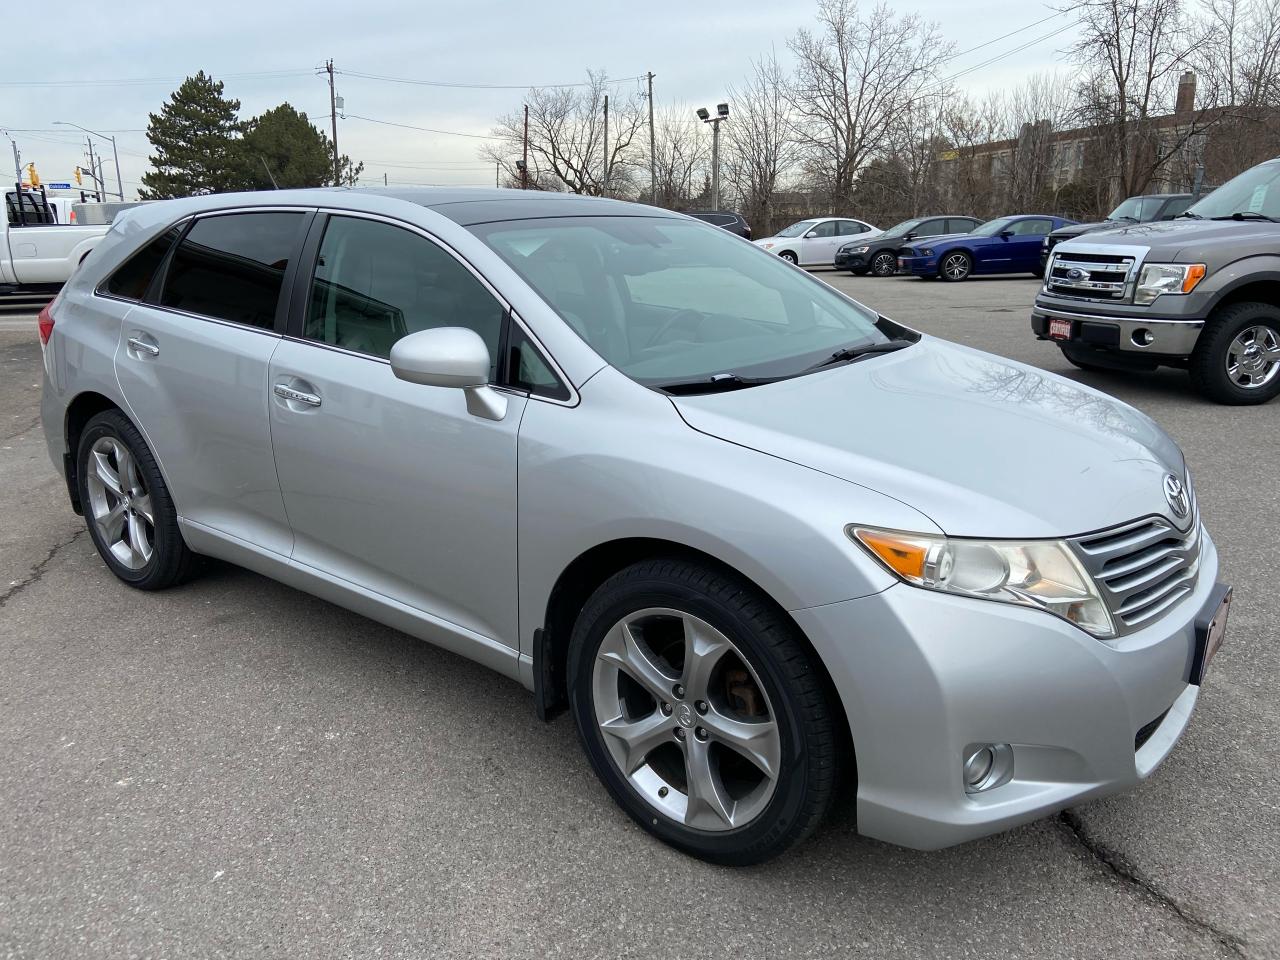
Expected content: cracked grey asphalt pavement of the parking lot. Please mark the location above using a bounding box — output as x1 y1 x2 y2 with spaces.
0 273 1280 960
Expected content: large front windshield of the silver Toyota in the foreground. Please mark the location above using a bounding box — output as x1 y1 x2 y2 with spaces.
468 216 890 387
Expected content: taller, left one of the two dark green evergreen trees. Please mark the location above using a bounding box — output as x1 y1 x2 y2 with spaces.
140 70 246 200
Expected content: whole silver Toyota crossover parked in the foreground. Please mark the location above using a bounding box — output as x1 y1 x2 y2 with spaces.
40 188 1229 864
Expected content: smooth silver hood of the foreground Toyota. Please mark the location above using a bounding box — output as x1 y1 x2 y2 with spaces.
672 337 1184 539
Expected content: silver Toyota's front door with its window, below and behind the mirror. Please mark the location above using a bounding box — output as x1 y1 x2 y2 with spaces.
270 209 527 646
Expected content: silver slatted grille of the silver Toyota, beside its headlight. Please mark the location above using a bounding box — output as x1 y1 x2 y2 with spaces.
1071 506 1202 634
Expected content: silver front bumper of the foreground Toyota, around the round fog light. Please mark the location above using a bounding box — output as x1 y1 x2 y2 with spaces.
792 534 1217 850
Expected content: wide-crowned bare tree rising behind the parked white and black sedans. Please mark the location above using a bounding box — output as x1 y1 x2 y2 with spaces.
790 0 951 207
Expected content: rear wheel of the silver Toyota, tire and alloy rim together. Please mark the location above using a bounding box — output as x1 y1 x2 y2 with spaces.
76 410 196 590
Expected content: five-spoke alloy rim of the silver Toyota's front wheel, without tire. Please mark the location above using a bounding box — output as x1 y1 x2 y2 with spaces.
591 608 782 831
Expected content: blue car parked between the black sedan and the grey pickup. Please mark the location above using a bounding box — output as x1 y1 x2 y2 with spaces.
897 214 1075 280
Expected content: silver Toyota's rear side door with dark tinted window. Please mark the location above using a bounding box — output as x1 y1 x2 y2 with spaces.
115 209 314 556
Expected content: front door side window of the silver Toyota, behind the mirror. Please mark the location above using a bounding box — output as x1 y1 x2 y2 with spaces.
303 216 506 380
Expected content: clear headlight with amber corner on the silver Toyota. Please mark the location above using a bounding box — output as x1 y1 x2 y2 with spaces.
846 526 1115 637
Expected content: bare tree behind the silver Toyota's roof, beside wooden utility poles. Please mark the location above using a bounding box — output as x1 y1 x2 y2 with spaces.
480 72 648 196
